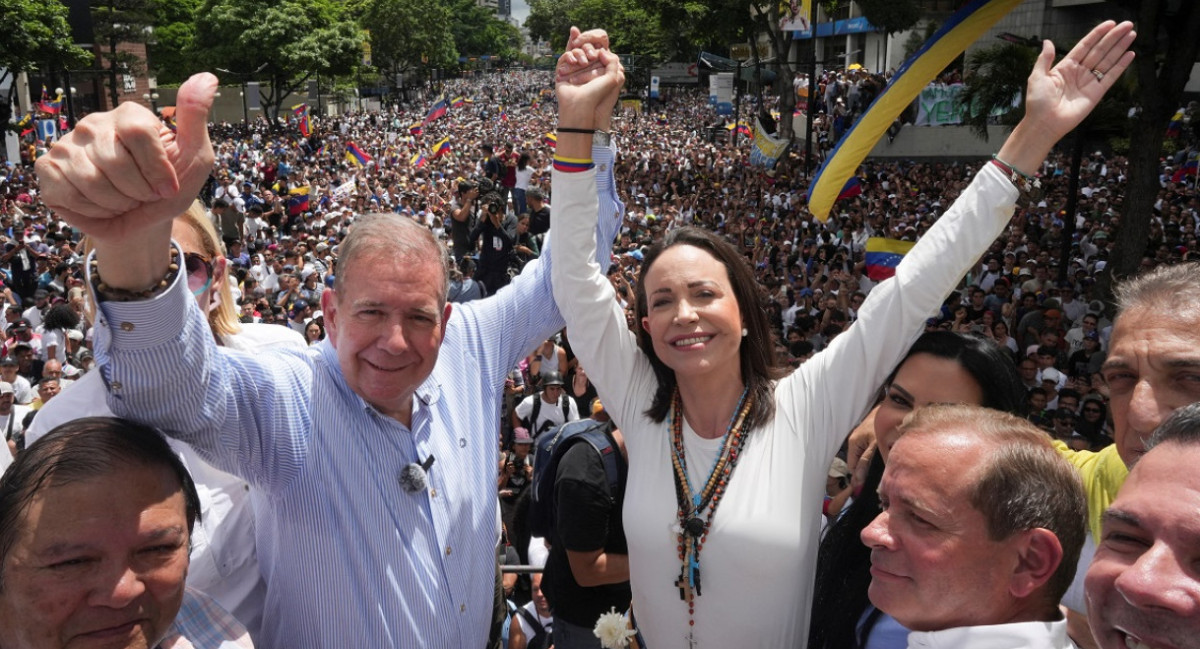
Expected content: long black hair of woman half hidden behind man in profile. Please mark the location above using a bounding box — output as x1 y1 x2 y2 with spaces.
808 331 1026 649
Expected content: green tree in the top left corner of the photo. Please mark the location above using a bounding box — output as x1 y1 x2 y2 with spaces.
0 0 91 148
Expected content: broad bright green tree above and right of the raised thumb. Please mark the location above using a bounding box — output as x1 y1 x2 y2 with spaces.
190 0 366 121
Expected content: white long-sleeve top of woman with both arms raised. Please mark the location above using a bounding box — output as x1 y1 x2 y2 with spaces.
551 164 1018 649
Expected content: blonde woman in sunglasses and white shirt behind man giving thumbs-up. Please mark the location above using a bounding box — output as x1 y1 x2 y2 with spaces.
25 202 307 635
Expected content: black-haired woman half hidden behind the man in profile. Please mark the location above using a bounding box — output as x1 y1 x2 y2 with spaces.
808 331 1025 649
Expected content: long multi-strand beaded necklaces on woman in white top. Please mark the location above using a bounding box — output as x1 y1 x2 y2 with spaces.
671 387 754 643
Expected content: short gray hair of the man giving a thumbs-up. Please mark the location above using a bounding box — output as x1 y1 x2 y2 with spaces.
334 212 450 306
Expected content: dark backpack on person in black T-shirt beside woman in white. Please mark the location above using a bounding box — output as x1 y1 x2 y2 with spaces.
528 419 622 539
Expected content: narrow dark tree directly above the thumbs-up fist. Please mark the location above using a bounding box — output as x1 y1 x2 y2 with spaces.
91 0 154 107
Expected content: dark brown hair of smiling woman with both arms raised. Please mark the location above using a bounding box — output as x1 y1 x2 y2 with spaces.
635 228 785 429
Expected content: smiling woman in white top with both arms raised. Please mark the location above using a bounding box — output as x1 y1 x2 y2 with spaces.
550 22 1134 649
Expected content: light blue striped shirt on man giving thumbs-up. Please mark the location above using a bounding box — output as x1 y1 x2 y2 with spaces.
88 143 624 649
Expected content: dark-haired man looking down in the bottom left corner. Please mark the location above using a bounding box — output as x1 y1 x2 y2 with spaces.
0 417 253 649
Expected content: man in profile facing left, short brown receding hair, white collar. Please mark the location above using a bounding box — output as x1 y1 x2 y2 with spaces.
862 405 1087 649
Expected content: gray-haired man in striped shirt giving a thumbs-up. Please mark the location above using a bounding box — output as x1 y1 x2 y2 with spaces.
38 68 624 649
